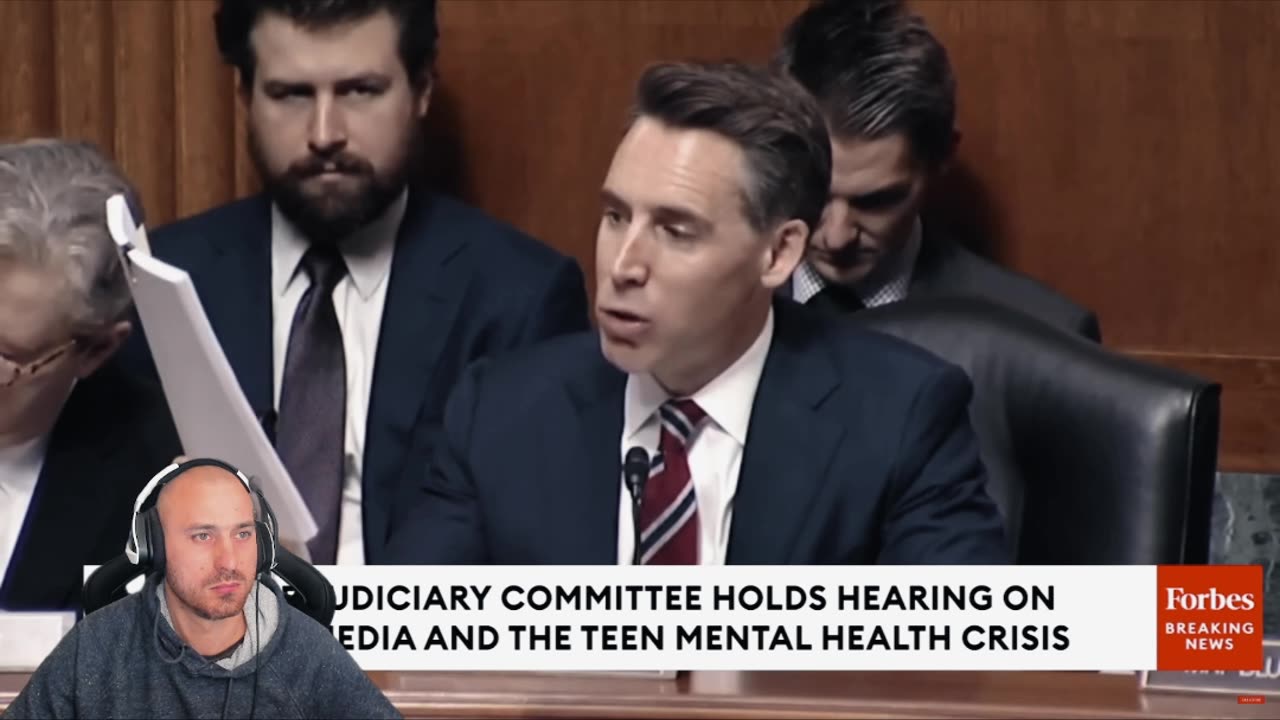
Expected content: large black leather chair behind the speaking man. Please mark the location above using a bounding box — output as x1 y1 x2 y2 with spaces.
852 297 1221 565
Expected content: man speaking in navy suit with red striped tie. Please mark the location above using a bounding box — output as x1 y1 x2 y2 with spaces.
388 64 1006 564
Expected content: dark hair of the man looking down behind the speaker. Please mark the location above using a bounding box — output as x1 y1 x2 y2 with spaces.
776 0 956 168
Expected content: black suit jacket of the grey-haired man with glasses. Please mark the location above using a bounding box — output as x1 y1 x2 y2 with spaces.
0 363 182 611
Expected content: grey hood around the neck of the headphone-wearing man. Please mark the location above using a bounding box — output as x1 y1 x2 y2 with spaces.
140 574 288 679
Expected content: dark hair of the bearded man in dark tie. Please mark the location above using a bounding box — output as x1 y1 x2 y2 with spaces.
214 0 440 88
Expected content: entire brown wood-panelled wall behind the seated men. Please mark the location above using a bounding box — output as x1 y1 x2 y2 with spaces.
0 0 1280 470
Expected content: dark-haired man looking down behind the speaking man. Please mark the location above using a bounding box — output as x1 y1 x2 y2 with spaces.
777 0 1101 341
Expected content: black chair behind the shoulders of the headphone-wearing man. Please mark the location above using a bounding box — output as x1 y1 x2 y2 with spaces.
82 547 338 626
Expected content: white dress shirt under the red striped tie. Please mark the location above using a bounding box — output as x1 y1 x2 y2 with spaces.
618 309 773 565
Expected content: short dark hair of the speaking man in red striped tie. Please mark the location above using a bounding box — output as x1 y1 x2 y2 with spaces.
632 63 831 231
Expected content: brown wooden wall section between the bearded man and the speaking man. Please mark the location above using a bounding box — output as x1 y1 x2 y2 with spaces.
433 0 804 272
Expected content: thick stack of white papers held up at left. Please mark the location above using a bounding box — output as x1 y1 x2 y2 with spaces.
106 195 316 560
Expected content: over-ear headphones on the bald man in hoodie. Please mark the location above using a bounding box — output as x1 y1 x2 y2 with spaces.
124 457 279 575
